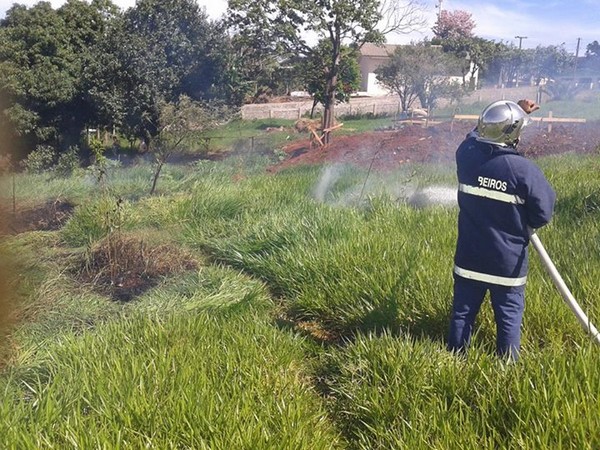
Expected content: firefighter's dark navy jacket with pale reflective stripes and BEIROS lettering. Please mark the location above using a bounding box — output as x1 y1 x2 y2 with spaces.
454 132 556 286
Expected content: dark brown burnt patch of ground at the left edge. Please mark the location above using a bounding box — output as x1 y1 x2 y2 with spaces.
0 200 75 236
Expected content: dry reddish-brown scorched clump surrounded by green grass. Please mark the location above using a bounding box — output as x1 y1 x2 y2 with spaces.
77 234 198 301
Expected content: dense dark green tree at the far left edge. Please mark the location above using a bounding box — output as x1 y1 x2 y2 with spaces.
0 0 112 153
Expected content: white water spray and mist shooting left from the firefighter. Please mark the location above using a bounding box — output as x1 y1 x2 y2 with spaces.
313 164 457 208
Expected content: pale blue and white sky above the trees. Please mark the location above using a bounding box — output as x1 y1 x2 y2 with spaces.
0 0 600 56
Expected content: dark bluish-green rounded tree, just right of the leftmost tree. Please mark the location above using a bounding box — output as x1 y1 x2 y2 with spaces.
86 0 227 144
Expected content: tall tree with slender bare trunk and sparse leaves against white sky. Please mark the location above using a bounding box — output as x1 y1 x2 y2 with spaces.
228 0 423 143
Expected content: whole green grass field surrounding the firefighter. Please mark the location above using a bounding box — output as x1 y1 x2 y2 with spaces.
0 108 600 449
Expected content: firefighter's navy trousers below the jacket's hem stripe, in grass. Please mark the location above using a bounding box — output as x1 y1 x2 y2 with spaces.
448 274 525 360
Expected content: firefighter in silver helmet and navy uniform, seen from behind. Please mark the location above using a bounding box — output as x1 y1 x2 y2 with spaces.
448 100 556 360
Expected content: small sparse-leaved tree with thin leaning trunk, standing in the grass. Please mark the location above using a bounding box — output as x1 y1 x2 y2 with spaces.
150 96 229 195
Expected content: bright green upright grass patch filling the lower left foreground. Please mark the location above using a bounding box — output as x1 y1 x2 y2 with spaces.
0 313 341 449
